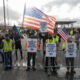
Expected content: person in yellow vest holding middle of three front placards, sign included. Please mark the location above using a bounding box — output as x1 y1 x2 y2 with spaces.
45 36 56 72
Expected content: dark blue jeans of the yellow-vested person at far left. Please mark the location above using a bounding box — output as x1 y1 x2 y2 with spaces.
4 52 12 68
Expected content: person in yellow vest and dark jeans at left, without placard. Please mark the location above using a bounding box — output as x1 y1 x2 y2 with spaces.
2 34 13 70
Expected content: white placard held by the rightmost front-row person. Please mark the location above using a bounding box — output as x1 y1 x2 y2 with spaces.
66 43 76 57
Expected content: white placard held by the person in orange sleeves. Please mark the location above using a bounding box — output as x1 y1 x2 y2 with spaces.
27 39 37 52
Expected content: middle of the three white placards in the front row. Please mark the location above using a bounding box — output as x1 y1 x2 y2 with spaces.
46 43 56 57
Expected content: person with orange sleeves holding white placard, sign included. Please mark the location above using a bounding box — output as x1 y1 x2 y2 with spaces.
25 36 39 71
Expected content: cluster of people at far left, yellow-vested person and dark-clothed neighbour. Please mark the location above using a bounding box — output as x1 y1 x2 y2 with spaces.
0 30 23 70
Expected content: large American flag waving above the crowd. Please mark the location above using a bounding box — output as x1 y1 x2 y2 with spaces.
23 8 56 34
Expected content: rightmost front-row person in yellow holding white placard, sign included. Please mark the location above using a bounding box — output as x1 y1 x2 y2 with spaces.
62 37 76 73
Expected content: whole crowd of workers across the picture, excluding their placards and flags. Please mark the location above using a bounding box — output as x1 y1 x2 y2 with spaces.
0 29 79 73
